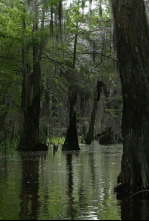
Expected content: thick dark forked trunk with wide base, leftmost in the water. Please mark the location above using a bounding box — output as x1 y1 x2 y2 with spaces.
19 0 47 151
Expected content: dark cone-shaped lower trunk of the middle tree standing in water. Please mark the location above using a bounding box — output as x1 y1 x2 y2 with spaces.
63 91 80 150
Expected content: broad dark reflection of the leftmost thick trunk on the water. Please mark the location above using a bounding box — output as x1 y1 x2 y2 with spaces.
20 153 44 220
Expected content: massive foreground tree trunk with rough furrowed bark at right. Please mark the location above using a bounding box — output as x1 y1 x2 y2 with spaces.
112 0 149 193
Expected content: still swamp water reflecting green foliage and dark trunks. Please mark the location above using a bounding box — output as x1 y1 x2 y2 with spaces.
0 142 149 220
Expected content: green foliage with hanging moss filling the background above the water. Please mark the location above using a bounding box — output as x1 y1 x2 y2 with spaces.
0 0 121 147
